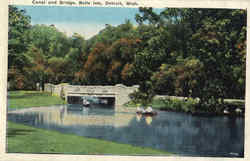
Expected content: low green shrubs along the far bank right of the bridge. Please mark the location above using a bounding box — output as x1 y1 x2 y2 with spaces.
125 97 245 116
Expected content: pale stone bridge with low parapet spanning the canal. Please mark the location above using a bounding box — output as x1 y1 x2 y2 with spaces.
45 84 138 105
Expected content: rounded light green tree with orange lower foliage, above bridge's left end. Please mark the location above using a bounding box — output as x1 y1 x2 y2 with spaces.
24 25 74 87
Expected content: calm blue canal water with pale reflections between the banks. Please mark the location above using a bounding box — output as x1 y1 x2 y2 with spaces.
8 105 244 157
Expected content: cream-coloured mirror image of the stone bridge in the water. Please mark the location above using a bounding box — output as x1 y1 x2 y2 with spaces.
8 106 138 127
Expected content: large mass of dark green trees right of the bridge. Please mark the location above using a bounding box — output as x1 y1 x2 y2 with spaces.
134 8 246 107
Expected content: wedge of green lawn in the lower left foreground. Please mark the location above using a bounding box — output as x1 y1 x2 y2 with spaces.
7 122 170 155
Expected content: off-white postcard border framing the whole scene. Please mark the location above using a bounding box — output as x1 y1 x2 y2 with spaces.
0 0 250 161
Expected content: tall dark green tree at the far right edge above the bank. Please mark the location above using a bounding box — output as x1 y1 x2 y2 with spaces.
190 10 246 109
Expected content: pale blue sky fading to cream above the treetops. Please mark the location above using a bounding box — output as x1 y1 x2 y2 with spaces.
17 6 164 39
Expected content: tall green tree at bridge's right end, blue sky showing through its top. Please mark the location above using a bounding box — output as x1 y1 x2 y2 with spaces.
132 8 191 105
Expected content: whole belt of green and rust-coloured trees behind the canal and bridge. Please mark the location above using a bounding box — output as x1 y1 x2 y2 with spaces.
8 6 247 112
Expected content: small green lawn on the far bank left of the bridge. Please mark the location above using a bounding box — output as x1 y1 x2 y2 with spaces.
8 91 65 108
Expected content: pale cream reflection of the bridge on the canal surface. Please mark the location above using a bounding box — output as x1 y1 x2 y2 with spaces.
9 105 135 127
